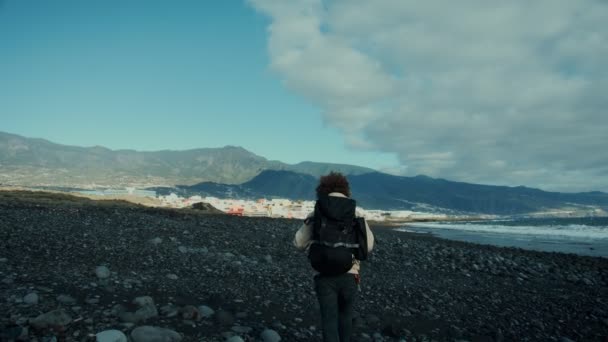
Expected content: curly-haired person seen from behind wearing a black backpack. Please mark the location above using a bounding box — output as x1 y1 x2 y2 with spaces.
293 172 374 342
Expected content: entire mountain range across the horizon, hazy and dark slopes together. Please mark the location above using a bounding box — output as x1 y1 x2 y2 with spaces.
0 132 608 215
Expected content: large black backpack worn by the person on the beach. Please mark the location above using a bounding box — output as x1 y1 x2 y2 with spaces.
308 195 367 275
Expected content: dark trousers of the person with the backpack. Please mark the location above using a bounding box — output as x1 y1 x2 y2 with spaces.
315 273 357 342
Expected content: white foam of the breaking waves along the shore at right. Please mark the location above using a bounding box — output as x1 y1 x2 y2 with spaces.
404 223 608 240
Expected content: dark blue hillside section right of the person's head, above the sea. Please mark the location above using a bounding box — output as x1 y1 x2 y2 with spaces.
349 172 608 215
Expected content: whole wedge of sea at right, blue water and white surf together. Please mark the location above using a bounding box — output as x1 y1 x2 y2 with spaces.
399 217 608 258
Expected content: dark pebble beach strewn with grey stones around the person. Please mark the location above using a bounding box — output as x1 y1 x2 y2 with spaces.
0 192 608 342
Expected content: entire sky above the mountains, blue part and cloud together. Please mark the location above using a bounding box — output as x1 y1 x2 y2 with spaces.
0 0 608 191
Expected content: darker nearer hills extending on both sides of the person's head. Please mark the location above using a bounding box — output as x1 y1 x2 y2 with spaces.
151 171 608 215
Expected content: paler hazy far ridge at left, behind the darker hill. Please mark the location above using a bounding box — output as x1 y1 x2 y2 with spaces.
0 132 372 187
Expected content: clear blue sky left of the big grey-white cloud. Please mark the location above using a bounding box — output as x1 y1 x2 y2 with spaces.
0 0 396 167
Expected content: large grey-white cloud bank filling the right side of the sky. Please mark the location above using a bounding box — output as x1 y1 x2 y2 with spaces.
251 0 608 191
